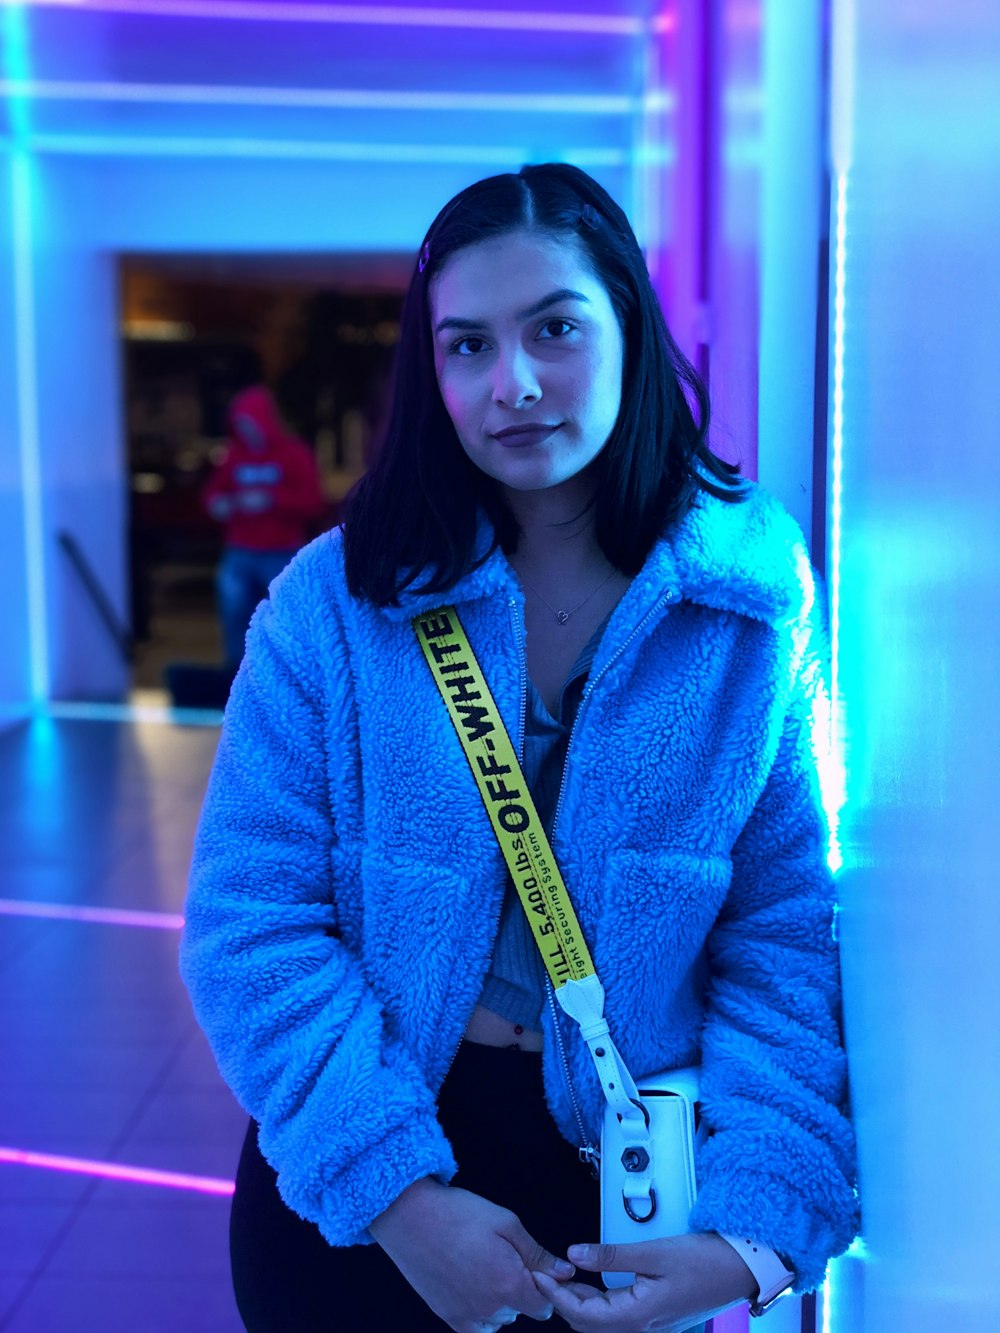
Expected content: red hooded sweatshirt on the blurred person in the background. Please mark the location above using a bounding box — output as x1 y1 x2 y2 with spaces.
201 385 327 551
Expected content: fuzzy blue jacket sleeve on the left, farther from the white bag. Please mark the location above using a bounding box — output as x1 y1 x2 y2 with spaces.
181 544 455 1245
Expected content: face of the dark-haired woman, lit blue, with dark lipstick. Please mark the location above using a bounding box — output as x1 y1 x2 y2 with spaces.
429 231 624 501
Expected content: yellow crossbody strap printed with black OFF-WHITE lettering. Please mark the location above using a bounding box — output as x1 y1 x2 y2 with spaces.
413 607 595 990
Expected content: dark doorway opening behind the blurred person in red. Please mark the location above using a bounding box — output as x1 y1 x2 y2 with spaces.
120 255 412 702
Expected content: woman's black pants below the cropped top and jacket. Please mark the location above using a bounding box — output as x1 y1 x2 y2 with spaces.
229 1041 599 1333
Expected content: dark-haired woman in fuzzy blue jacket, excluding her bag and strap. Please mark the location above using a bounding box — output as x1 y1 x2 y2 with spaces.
183 165 855 1333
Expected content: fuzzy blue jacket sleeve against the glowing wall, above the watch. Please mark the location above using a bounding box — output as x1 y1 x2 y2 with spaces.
691 599 857 1290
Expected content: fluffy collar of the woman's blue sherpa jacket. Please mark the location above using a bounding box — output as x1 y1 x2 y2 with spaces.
383 483 813 627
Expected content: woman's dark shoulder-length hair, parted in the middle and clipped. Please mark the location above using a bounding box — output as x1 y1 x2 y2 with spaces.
344 163 743 605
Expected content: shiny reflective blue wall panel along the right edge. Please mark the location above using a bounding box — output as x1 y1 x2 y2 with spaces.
831 0 1000 1333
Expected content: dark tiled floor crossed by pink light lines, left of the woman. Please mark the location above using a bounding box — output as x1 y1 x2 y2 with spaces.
0 720 245 1333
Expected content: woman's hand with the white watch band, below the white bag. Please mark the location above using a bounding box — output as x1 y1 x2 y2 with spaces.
535 1232 757 1333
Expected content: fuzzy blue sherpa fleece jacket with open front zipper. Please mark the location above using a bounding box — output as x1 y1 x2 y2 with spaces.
181 487 856 1290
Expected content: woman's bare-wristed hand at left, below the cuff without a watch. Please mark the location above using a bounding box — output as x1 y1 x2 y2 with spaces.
369 1177 576 1333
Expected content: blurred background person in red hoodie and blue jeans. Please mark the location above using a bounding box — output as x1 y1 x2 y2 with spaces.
201 385 327 672
